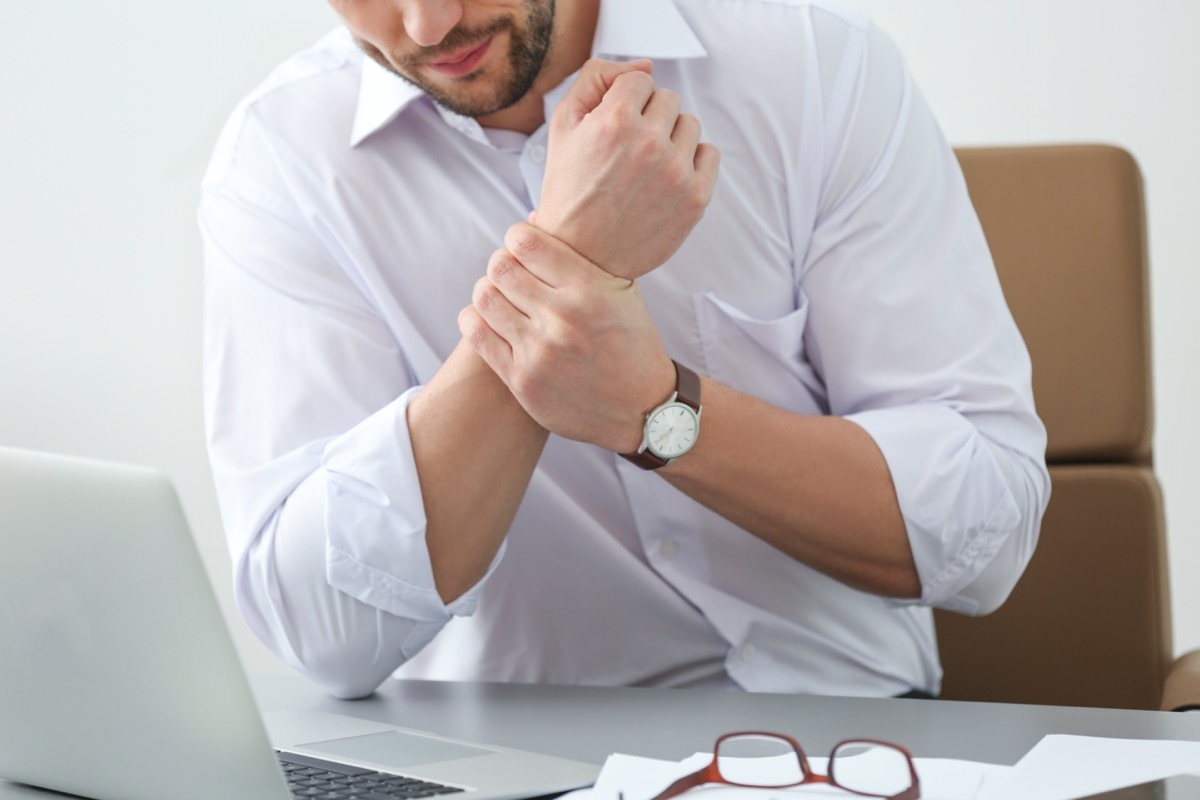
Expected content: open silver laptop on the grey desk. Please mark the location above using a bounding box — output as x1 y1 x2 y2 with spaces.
0 447 599 800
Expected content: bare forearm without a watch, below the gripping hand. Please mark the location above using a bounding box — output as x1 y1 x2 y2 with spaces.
408 341 548 602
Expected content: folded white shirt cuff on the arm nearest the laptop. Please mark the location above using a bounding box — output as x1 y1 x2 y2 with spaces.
322 386 505 627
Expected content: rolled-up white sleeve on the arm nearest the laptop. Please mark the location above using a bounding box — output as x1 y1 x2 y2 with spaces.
199 109 503 697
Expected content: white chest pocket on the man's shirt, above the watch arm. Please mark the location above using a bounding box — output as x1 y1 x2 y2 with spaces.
692 291 828 414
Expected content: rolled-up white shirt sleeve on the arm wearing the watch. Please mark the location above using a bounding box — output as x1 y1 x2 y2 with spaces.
799 23 1050 614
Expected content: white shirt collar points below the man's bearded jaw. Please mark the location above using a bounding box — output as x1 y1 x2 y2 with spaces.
350 0 707 148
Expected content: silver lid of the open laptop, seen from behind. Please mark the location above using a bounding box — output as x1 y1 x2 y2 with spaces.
0 447 289 800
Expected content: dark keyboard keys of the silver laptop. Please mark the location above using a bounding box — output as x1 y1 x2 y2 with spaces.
275 752 462 800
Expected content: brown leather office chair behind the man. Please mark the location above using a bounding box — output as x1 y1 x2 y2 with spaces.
936 145 1200 709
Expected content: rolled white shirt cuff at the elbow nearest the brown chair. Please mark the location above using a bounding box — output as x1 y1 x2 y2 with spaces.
846 403 1022 614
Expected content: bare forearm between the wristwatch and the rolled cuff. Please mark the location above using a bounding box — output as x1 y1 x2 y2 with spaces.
659 379 920 599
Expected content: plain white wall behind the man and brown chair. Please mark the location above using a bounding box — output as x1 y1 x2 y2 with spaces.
0 0 1200 672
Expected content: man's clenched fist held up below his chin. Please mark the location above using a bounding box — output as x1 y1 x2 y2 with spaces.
533 59 720 279
